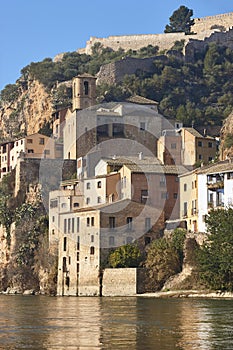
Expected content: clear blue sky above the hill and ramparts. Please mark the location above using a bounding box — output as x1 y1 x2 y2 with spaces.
0 0 233 90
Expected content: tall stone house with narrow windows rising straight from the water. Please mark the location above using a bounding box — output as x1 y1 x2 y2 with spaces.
57 200 164 296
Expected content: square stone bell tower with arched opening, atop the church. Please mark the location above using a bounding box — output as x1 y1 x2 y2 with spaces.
72 74 96 111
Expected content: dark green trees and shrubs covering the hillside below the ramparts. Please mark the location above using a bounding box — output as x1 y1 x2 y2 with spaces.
0 35 233 139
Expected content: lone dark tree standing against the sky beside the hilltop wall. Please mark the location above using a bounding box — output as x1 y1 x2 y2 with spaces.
164 6 194 34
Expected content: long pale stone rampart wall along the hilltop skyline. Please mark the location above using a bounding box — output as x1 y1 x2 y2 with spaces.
78 12 233 55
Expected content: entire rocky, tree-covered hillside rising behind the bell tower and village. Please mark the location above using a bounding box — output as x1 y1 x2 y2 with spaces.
0 14 233 142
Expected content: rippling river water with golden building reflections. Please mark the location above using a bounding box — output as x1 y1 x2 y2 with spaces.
0 295 233 350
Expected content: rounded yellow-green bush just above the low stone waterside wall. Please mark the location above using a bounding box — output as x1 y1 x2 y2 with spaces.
108 244 142 268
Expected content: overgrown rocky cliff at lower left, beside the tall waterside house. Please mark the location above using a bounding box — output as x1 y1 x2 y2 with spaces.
0 171 57 294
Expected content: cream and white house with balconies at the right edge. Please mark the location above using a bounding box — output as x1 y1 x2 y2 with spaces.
180 160 233 232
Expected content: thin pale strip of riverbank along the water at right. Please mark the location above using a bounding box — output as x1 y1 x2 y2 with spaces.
137 290 233 299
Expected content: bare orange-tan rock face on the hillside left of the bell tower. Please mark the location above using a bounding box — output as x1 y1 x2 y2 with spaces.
0 80 52 141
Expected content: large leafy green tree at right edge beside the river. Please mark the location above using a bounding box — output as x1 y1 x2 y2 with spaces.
198 208 233 292
